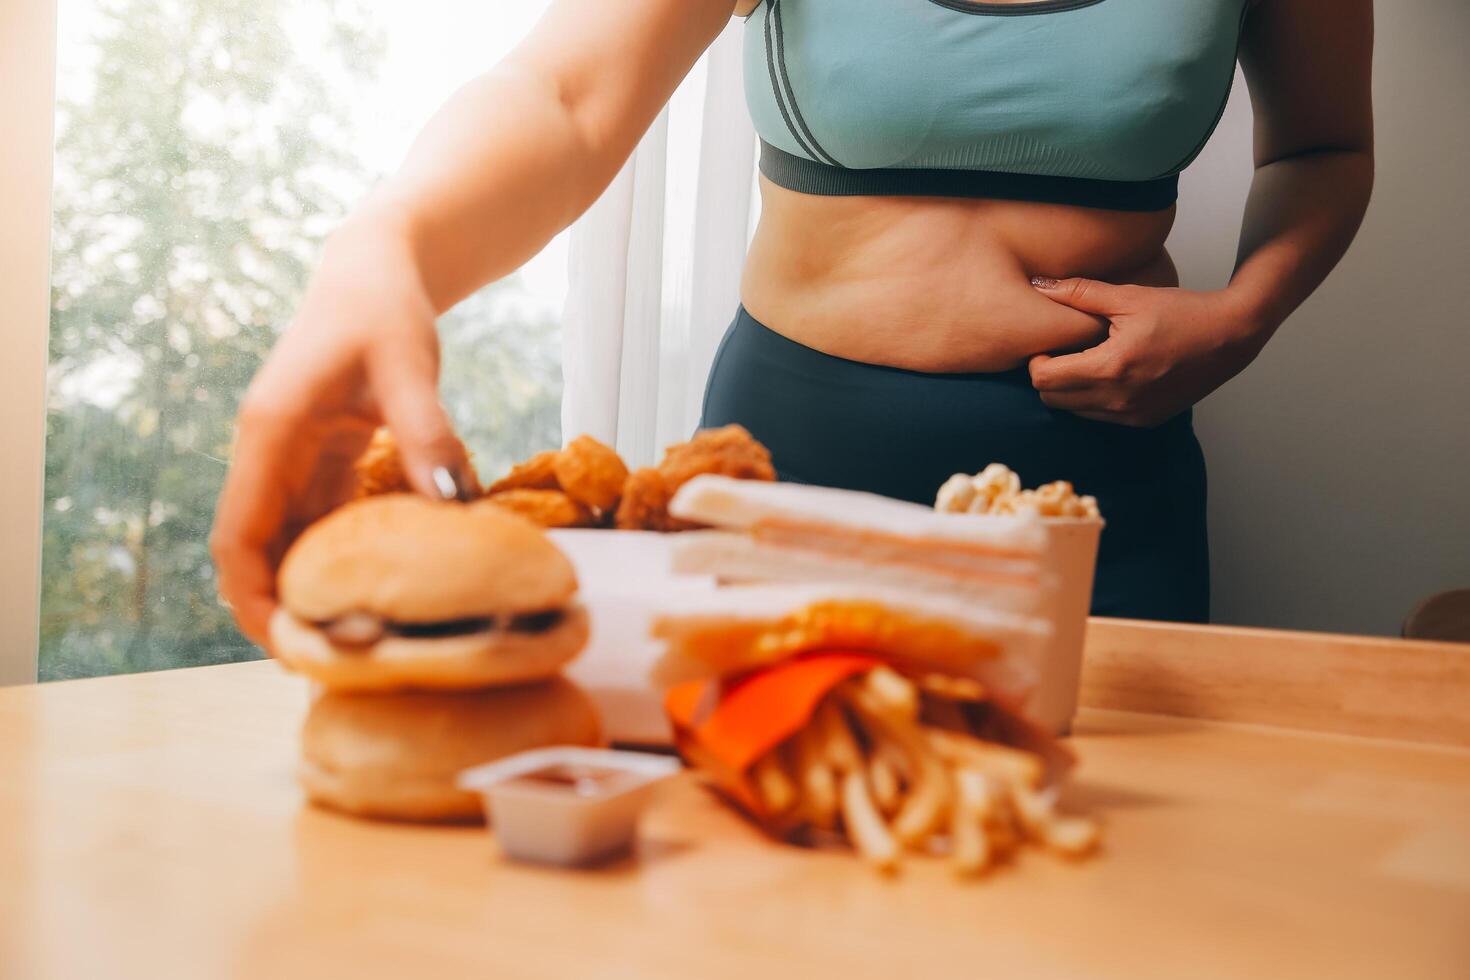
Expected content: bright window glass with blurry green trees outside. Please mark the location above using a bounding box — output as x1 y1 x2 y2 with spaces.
40 0 566 680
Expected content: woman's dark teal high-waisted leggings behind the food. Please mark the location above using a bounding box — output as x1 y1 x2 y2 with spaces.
701 309 1210 623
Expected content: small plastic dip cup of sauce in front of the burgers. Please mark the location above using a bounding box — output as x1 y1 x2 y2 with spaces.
456 746 681 865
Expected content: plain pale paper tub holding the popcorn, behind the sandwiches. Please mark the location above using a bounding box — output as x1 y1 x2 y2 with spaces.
1028 517 1104 735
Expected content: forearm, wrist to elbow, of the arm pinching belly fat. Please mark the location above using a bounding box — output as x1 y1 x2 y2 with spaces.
1227 150 1373 342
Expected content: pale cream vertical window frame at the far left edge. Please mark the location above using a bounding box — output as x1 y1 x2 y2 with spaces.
0 0 56 685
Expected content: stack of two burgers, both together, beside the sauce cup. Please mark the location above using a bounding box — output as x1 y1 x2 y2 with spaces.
270 494 601 821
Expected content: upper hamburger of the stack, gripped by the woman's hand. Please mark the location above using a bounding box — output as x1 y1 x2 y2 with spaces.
270 494 588 692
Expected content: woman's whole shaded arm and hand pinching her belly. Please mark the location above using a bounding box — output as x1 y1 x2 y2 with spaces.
1030 0 1373 426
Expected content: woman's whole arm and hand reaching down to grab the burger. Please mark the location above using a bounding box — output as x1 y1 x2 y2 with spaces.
210 0 734 644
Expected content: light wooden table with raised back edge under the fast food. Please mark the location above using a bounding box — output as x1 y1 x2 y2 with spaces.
0 624 1470 980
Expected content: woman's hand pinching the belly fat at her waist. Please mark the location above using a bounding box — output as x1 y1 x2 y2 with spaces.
1030 276 1266 426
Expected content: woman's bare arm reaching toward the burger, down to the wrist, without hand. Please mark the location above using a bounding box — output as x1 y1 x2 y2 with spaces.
366 0 735 311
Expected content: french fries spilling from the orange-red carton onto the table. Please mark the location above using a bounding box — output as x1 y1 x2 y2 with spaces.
750 667 1101 877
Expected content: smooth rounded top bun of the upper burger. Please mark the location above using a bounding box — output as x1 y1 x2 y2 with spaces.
278 494 576 623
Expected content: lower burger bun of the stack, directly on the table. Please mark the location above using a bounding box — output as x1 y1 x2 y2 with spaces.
298 677 601 823
